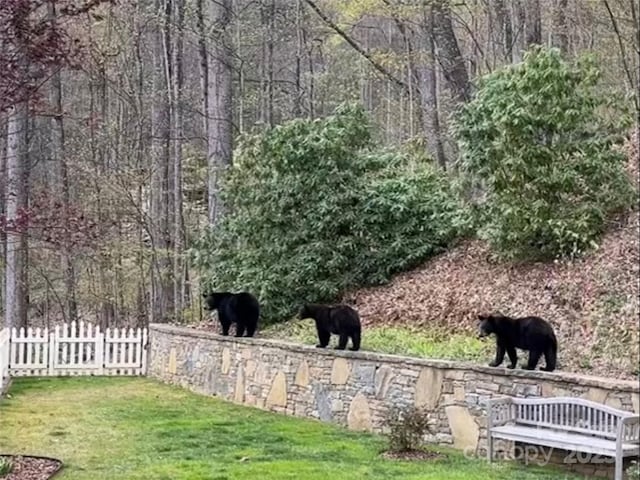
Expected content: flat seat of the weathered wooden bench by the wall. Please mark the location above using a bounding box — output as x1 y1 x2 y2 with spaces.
491 425 640 457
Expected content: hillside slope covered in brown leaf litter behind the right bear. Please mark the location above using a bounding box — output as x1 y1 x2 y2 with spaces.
345 137 640 378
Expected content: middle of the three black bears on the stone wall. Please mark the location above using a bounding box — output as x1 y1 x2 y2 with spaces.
298 304 361 351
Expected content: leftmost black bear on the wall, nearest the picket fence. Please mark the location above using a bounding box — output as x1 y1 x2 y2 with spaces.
202 292 260 337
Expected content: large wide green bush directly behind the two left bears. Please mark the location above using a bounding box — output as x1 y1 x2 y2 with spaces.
193 107 465 323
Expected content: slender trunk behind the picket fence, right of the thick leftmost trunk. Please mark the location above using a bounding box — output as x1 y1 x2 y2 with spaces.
48 2 78 322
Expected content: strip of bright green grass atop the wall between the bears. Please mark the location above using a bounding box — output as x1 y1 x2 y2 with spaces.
260 320 495 361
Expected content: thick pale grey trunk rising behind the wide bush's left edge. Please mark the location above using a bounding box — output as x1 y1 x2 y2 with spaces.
207 0 233 225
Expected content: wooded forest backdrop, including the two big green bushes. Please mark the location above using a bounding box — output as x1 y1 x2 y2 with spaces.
0 0 640 360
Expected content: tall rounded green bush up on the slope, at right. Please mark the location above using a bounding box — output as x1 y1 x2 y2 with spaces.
455 47 634 259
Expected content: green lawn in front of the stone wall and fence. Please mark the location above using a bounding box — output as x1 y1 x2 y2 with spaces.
0 378 576 480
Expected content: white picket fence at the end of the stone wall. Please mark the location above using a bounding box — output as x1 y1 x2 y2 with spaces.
0 322 147 382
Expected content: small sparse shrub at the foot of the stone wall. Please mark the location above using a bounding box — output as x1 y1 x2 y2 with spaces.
384 406 431 452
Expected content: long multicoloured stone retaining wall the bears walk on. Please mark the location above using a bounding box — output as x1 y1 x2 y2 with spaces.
148 324 640 476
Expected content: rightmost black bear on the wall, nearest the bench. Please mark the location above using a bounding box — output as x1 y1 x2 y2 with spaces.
478 315 558 372
